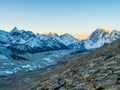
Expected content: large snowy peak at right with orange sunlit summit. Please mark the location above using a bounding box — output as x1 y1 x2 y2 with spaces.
72 28 120 50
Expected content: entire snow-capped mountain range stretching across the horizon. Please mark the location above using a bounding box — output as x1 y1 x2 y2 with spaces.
0 27 120 53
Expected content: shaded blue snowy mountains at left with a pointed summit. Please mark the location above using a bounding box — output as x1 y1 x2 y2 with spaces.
0 27 67 53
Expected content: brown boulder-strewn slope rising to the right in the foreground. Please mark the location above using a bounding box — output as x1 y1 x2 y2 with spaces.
22 40 120 90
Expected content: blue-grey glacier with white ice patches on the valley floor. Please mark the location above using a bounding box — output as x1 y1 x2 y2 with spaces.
0 50 74 76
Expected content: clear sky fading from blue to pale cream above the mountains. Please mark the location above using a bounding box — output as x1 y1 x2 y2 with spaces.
0 0 120 38
